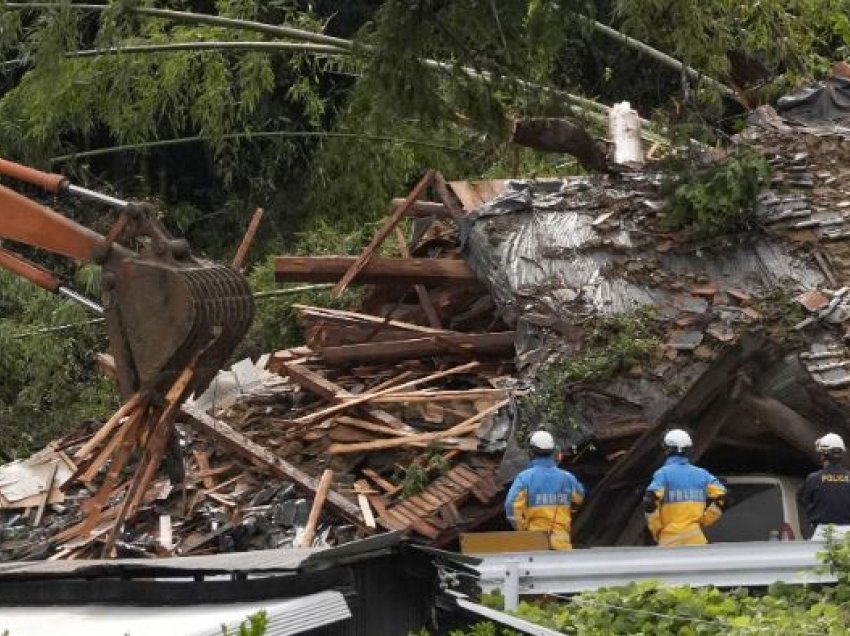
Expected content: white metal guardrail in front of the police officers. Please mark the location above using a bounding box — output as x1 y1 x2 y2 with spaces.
474 541 835 610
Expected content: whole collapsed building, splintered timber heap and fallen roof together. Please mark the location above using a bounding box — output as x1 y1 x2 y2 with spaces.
0 109 850 559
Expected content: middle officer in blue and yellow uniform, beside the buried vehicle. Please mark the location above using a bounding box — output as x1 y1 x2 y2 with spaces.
644 429 726 547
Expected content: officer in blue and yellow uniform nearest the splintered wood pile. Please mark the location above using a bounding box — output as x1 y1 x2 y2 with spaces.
505 431 584 550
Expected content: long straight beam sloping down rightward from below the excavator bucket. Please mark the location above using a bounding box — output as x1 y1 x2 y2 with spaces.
182 404 364 528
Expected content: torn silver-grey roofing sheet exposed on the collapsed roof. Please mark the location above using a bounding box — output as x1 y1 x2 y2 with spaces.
464 179 824 323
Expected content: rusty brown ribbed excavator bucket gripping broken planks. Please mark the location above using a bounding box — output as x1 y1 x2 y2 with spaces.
104 257 254 394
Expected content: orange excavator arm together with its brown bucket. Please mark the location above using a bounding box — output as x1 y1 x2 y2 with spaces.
0 159 254 396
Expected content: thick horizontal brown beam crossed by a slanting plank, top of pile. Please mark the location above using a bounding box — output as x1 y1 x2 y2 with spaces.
274 256 477 285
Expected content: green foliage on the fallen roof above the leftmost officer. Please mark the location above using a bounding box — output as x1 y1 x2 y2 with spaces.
521 308 659 430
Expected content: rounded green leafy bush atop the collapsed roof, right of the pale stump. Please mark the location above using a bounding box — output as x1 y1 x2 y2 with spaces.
662 149 771 237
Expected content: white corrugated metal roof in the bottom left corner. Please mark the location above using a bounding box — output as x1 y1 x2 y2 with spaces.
0 591 351 636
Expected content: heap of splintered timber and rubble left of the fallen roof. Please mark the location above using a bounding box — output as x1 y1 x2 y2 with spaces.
0 172 518 559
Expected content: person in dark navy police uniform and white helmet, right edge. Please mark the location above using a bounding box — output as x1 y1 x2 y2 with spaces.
802 433 850 541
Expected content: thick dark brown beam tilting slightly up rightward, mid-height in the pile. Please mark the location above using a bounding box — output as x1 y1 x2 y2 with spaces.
318 331 516 366
